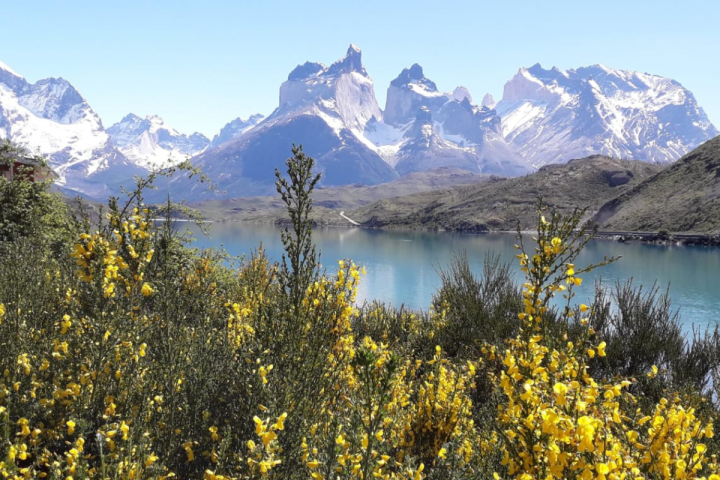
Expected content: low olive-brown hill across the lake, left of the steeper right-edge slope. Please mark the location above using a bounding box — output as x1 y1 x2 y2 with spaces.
347 155 661 232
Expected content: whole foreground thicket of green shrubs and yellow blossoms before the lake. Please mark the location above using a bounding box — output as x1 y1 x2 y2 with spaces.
0 143 720 480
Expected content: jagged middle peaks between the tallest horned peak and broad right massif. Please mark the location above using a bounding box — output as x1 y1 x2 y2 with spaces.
365 64 530 176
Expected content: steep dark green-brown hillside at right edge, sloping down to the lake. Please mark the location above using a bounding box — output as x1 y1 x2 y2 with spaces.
593 137 720 234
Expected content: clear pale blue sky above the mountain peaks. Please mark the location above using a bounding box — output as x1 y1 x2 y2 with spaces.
0 0 720 136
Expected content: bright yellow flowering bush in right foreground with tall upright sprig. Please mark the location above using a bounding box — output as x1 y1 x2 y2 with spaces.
495 207 717 480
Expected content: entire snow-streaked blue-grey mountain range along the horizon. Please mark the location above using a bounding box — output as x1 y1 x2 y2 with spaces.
0 45 718 200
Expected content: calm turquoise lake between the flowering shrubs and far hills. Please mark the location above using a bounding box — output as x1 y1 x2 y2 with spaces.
191 223 720 328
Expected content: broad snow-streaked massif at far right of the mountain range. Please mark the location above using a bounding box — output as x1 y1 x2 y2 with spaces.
496 64 718 167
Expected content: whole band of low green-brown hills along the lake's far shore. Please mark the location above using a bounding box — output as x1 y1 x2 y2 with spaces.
193 136 720 237
